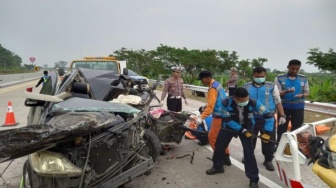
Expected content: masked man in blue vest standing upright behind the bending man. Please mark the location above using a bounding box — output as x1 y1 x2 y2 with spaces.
243 67 286 171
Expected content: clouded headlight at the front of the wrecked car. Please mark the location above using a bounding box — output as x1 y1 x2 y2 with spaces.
29 151 83 177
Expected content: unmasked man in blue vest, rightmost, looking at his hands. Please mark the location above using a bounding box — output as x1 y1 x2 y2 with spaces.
274 59 309 142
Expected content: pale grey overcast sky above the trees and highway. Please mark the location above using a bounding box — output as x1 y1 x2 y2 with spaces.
0 0 336 72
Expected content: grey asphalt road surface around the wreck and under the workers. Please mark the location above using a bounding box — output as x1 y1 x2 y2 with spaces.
0 80 285 188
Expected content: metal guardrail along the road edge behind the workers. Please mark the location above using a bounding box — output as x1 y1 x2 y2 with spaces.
148 79 336 116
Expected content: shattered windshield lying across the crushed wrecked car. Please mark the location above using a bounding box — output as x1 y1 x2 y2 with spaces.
52 97 140 114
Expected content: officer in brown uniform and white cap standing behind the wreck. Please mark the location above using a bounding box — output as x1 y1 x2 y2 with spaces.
161 68 188 112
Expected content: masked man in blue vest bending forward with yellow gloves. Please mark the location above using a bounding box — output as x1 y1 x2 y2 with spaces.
206 88 274 187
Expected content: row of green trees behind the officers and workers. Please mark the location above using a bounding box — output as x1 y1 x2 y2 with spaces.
110 44 336 84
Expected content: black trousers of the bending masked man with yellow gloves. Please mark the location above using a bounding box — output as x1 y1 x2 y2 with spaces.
212 129 259 182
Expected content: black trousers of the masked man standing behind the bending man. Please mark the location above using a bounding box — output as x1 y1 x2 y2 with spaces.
253 117 276 162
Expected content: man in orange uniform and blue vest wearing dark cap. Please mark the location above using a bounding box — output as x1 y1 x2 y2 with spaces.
196 70 231 166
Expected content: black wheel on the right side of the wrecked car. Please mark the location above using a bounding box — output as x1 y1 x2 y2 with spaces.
140 129 161 162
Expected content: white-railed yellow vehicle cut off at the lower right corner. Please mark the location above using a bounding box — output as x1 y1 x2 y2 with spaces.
275 117 336 188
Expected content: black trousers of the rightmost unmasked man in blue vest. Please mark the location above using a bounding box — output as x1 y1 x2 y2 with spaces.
277 108 304 142
